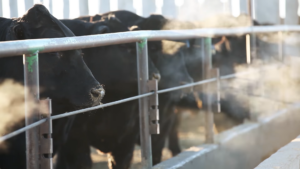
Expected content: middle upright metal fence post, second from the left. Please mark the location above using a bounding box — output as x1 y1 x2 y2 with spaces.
136 38 152 169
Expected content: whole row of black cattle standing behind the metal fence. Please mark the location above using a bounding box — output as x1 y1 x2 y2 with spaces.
0 5 258 169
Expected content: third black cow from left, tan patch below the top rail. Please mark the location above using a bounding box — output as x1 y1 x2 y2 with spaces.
79 10 193 164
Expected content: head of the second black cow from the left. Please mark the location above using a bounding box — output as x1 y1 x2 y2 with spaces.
62 16 160 102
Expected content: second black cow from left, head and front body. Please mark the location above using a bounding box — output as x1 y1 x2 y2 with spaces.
56 17 160 169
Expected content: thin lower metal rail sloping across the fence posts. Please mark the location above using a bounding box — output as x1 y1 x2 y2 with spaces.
0 67 259 143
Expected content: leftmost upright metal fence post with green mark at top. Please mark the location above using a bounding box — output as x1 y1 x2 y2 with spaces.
23 51 40 169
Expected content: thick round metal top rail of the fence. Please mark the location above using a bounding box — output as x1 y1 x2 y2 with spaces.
0 25 300 57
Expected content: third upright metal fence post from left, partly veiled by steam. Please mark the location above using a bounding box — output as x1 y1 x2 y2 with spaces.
202 38 214 143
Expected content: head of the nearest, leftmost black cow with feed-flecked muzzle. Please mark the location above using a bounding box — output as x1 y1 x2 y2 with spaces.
8 5 104 107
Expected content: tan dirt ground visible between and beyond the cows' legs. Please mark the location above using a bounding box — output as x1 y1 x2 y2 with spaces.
92 110 238 169
